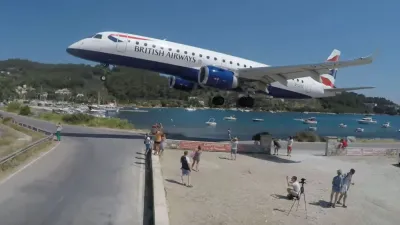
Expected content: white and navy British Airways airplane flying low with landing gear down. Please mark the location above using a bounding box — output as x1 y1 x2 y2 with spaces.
66 31 374 108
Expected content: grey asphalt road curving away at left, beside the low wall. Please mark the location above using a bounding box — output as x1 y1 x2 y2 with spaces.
0 112 145 225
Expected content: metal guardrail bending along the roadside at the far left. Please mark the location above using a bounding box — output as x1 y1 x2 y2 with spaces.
0 113 54 165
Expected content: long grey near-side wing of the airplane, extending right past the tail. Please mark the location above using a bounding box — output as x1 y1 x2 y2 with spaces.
238 52 373 83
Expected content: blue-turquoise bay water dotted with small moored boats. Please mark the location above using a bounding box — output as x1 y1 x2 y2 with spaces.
116 109 400 140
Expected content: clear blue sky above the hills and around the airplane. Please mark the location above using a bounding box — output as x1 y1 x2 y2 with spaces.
0 0 400 103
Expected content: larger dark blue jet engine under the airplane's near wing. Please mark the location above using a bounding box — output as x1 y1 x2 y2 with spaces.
198 66 239 90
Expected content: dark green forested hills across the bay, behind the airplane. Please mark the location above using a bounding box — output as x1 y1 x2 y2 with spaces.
0 59 400 114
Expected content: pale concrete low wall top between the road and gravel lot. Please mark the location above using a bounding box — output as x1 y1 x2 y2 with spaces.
151 155 169 225
